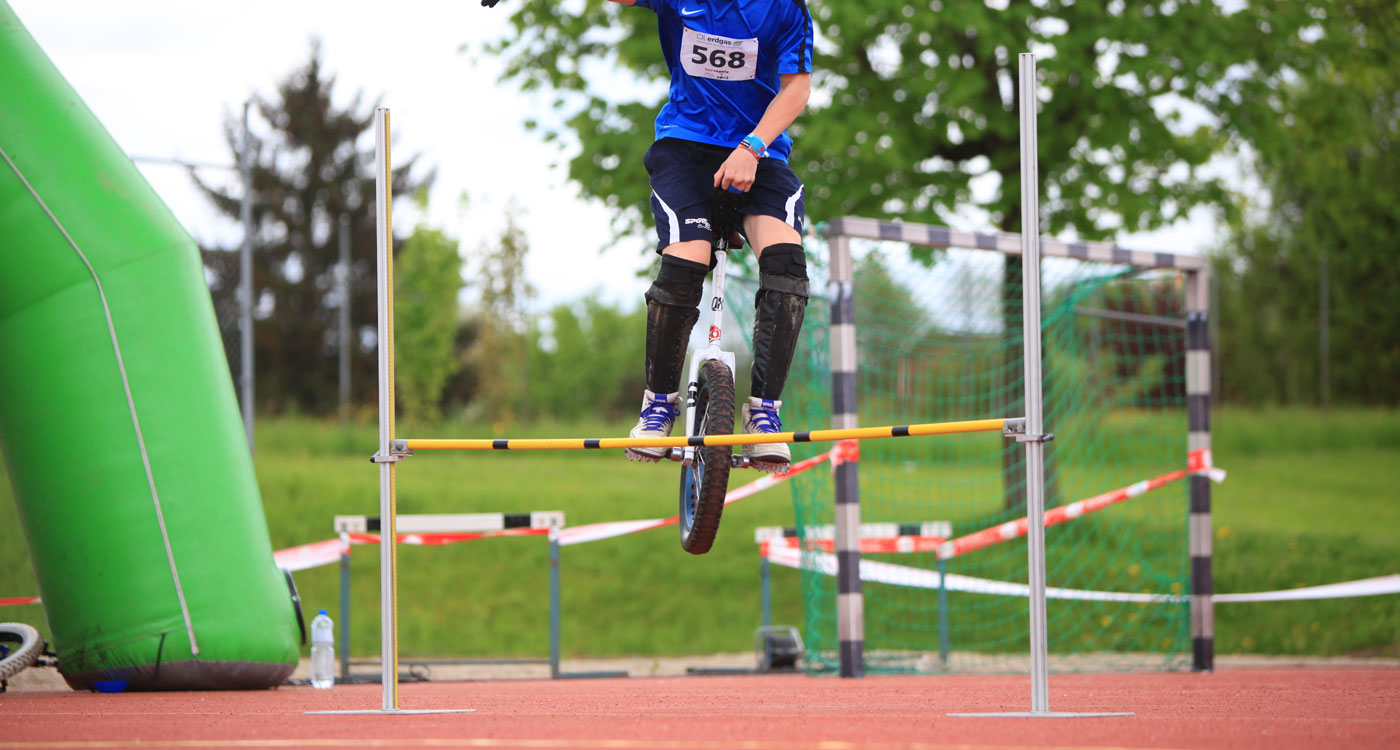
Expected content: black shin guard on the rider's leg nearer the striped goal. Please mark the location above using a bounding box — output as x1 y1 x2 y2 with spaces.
749 242 808 400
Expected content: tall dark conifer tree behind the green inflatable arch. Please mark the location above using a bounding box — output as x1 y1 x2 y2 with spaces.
195 42 433 414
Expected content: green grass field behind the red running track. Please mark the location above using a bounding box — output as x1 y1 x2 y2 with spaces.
0 410 1400 656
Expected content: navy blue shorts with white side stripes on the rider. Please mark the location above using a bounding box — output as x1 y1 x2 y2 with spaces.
644 139 806 253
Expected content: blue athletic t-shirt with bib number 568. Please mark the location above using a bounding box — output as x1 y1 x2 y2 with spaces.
636 0 812 161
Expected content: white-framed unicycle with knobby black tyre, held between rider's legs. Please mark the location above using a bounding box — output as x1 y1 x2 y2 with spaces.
671 190 745 554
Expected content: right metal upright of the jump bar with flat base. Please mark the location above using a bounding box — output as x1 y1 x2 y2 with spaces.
949 52 1133 718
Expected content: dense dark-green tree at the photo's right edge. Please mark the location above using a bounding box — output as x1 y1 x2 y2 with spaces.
1215 0 1400 406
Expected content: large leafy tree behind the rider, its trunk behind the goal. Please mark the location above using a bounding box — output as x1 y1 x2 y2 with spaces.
491 0 1330 505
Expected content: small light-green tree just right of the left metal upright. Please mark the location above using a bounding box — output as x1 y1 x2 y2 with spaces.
393 193 462 421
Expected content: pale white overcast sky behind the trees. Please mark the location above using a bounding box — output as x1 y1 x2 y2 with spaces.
8 0 1211 308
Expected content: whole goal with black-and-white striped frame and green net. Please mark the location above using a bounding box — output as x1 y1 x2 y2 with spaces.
735 217 1214 676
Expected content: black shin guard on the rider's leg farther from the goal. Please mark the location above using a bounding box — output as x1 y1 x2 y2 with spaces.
647 255 710 393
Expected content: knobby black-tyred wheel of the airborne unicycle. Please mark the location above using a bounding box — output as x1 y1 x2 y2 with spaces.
680 360 734 554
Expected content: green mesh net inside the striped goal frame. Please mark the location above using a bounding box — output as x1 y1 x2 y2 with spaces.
734 218 1191 673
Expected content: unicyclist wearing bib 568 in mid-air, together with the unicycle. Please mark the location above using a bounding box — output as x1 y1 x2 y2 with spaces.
482 0 812 553
